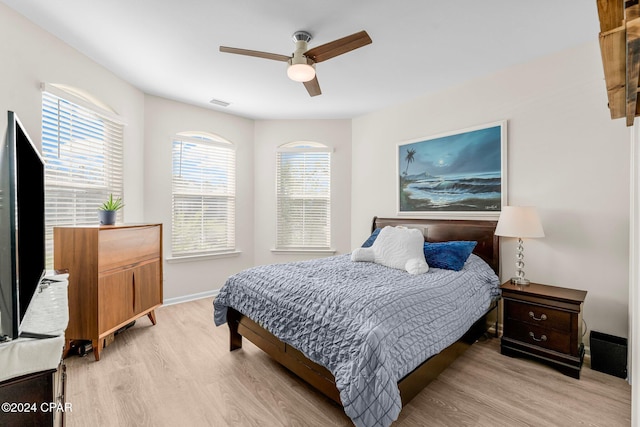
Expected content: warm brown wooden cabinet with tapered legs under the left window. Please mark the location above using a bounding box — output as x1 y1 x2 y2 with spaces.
53 224 163 361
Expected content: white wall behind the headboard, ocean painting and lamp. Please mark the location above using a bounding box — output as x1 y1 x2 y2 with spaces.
351 41 630 345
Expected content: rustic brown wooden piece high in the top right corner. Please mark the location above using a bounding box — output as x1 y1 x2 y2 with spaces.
597 0 640 126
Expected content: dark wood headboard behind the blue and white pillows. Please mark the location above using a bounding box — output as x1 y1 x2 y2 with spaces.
371 217 500 274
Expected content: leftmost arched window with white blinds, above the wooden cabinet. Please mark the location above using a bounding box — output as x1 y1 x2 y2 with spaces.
42 85 124 268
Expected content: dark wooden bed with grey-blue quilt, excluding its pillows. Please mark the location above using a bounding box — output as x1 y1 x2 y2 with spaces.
214 217 499 426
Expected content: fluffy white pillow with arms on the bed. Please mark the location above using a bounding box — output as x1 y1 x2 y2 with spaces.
351 226 429 274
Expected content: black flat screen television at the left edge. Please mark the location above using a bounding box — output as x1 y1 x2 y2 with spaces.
0 111 46 341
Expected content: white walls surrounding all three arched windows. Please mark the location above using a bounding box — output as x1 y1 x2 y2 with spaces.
0 0 351 301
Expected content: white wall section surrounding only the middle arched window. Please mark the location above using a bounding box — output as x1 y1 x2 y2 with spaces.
144 95 254 301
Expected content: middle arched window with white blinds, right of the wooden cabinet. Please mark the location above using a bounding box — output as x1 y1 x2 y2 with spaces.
171 132 236 257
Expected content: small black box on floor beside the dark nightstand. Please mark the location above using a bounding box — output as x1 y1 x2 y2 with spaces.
589 331 627 378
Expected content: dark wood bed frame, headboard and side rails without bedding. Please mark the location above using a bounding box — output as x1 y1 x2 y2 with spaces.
227 217 500 406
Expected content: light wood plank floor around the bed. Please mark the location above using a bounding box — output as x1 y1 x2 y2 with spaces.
66 298 631 427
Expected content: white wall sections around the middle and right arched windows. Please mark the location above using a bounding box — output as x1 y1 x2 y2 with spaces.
144 103 351 302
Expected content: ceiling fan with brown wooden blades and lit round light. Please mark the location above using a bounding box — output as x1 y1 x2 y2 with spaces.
220 31 371 96
